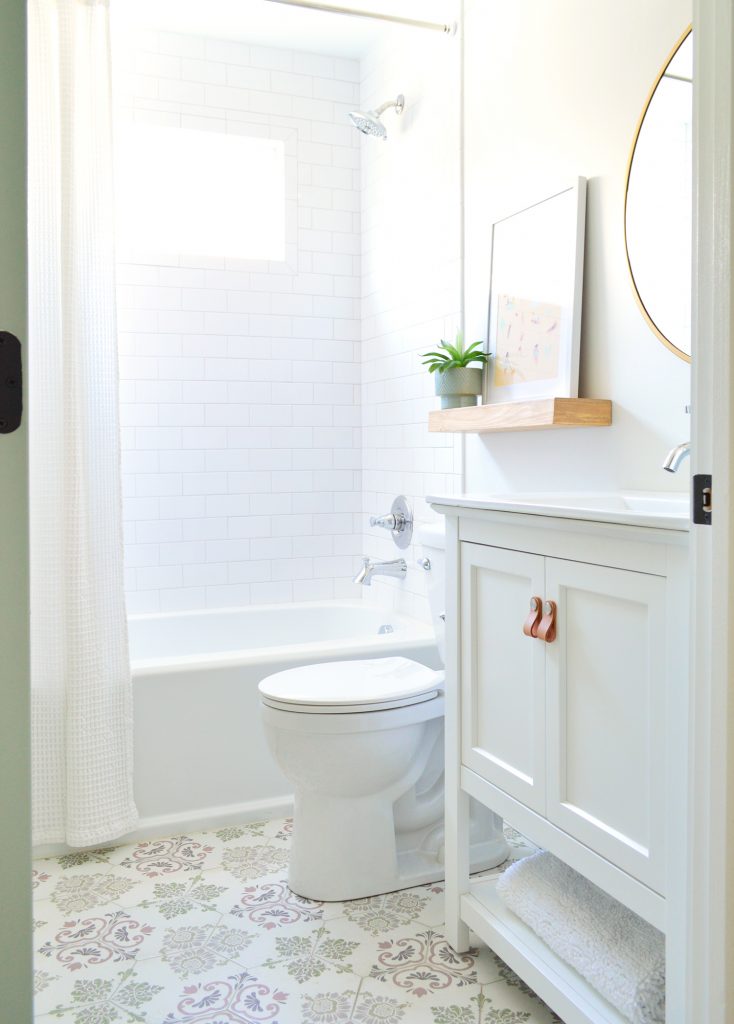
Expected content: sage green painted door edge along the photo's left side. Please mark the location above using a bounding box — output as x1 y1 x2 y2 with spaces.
0 0 33 1024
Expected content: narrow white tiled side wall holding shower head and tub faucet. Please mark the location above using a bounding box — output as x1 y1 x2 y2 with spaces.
360 16 461 616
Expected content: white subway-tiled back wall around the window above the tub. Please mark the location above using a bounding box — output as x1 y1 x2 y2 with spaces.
118 33 361 612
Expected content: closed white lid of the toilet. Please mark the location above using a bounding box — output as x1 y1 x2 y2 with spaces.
259 657 443 711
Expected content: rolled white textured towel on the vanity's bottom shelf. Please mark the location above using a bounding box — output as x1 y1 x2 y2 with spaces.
496 851 665 1024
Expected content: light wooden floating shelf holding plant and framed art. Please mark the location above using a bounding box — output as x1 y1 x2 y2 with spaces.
428 398 611 434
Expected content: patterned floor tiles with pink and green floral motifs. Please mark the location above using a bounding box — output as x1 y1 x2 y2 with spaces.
34 819 558 1024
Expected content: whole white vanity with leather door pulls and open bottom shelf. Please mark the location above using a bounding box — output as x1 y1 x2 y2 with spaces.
429 495 689 1024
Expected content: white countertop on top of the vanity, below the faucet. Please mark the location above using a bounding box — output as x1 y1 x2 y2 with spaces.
426 490 690 530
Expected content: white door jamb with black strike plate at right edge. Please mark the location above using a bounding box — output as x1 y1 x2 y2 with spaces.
686 0 734 1024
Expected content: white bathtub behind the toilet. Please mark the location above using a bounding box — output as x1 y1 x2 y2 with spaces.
130 601 440 838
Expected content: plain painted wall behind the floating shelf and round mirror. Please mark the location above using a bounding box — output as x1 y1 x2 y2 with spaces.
465 0 691 493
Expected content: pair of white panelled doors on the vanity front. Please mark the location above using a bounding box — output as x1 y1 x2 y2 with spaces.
461 543 665 893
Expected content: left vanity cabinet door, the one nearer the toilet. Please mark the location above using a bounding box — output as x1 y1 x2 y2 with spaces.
461 543 546 813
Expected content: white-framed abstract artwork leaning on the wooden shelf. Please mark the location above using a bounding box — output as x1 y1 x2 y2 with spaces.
484 178 587 402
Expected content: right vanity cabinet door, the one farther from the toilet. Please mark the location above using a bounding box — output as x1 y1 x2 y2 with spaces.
546 558 665 893
